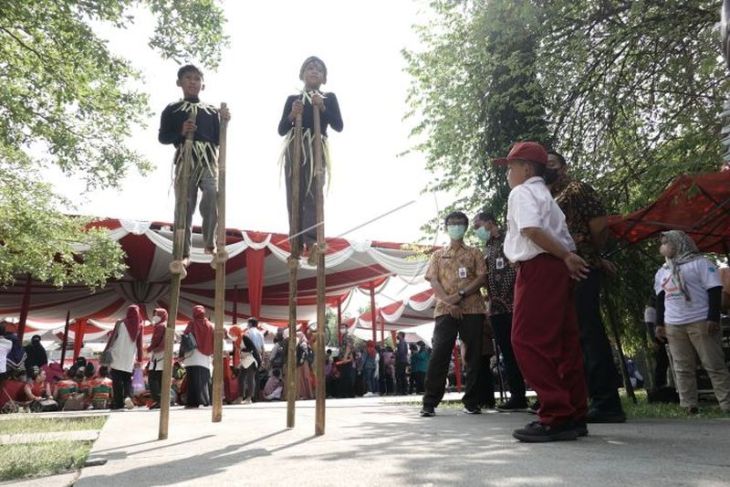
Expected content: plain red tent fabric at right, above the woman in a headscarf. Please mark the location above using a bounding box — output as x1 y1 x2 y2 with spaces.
609 171 730 254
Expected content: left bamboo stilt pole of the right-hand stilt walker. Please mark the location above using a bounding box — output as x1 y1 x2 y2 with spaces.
286 108 302 428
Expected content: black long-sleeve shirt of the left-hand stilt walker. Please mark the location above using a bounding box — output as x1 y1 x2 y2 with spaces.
158 97 220 147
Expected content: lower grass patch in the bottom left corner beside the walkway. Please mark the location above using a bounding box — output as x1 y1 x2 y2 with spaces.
0 441 93 481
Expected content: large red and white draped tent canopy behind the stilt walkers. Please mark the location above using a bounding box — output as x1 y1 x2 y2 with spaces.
0 219 426 333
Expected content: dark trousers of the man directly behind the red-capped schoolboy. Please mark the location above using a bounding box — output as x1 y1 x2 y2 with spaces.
575 269 623 412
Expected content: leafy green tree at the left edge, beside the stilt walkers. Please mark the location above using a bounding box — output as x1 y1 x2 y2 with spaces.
0 0 227 285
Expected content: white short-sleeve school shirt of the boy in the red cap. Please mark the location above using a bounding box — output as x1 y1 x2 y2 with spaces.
504 176 575 262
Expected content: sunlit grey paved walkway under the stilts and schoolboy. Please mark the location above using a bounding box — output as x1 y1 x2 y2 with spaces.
75 398 730 487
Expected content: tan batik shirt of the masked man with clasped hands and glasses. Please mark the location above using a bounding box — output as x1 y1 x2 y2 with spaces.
426 245 487 317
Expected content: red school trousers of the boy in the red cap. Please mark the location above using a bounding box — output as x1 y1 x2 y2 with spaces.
512 254 588 424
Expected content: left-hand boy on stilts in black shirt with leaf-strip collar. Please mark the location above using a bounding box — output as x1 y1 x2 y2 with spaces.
159 64 231 265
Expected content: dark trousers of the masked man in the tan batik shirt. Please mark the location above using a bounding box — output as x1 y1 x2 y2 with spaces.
423 314 484 407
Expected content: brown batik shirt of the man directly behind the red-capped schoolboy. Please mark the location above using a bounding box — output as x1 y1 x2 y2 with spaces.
551 179 606 267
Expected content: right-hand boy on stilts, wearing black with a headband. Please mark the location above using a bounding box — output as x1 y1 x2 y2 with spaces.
279 56 342 264
